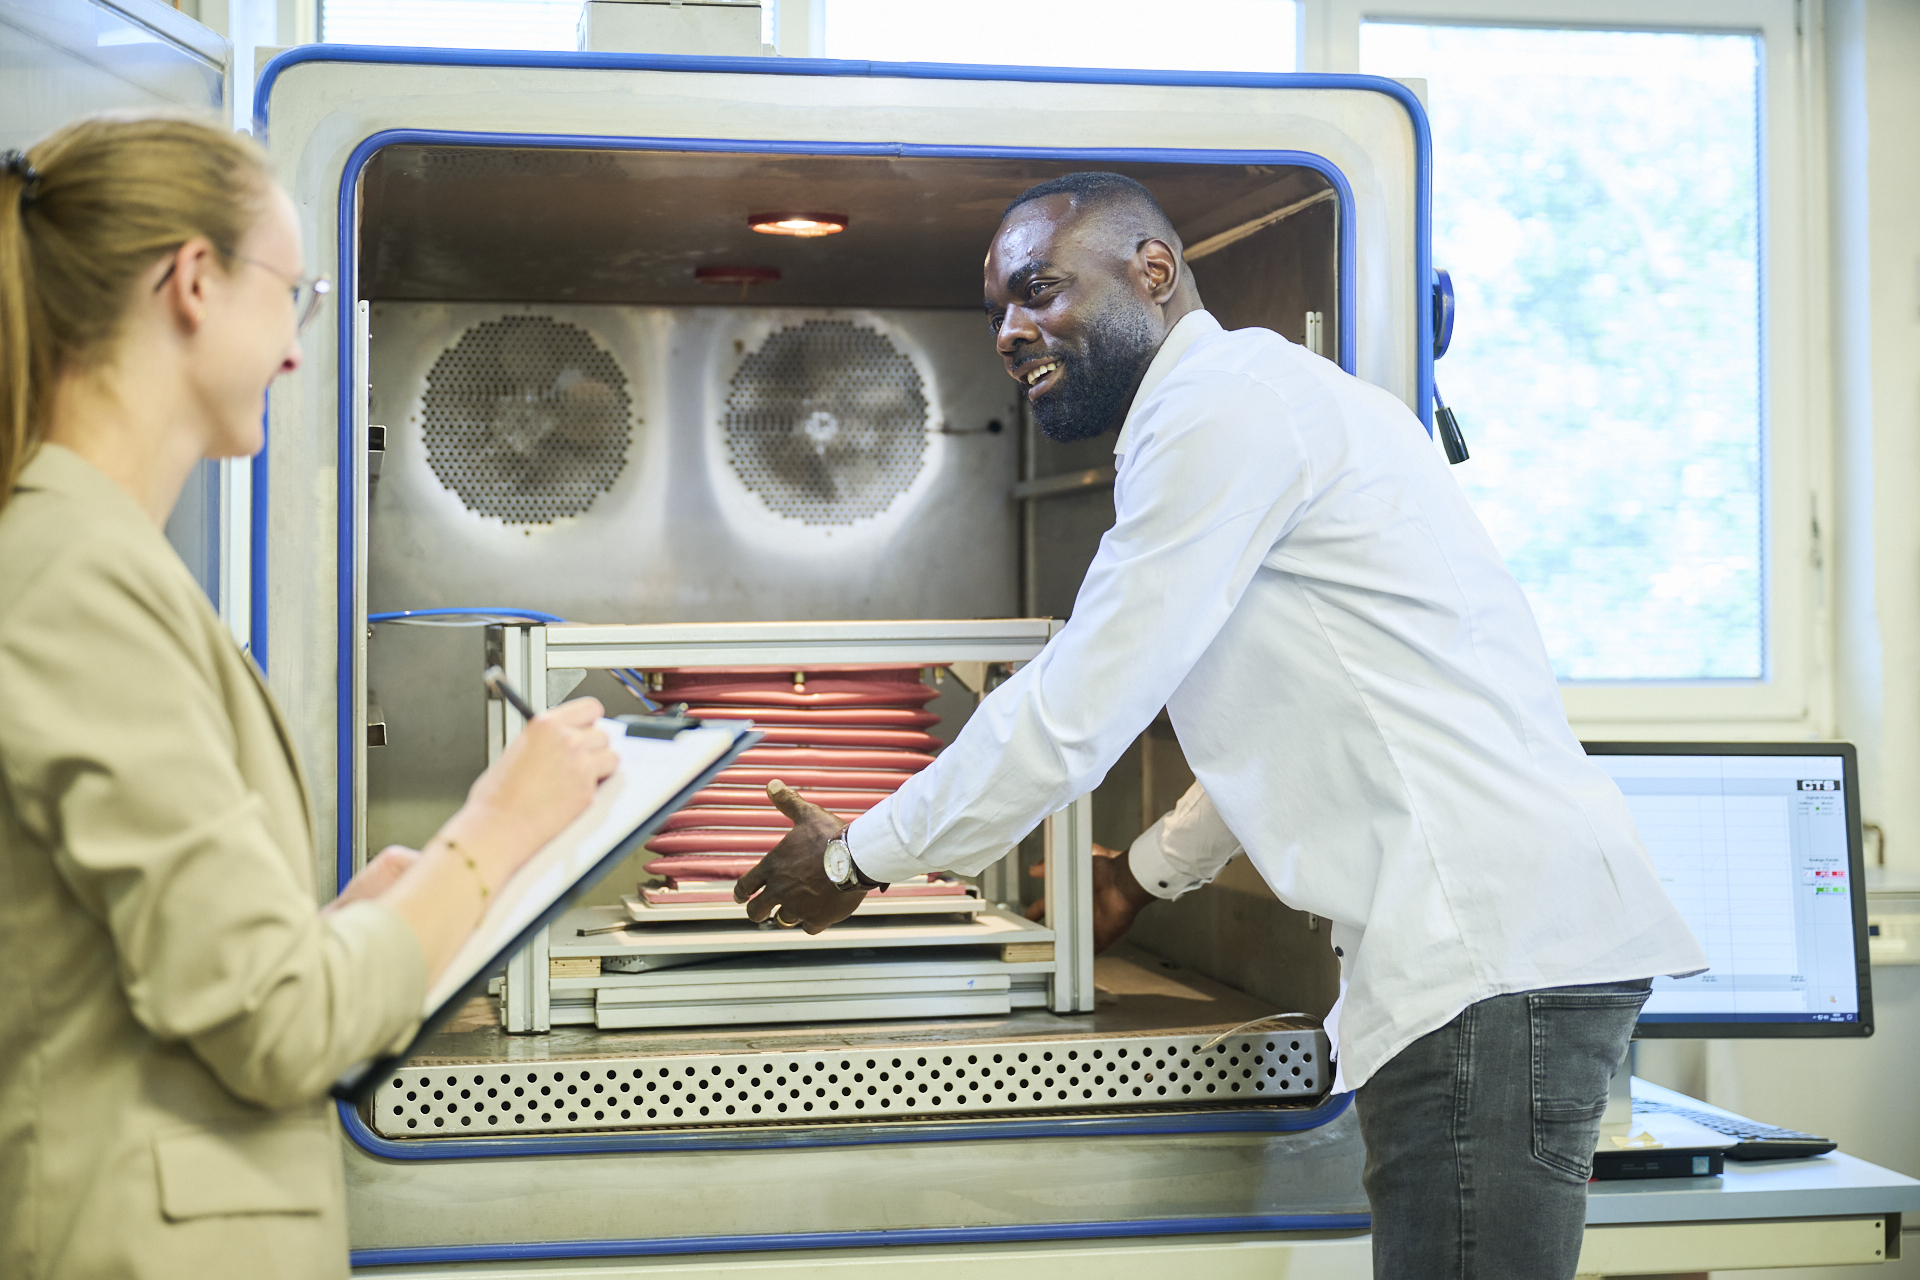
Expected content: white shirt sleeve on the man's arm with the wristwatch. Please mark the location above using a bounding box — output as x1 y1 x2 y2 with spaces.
847 368 1311 881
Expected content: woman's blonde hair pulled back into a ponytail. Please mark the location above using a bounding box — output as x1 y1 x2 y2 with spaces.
0 113 273 507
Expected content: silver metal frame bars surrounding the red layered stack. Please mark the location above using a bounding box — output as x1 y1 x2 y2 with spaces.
488 618 1094 1032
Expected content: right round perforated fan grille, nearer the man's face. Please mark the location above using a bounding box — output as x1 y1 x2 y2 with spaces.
720 320 927 524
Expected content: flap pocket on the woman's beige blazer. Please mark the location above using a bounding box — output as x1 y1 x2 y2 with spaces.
154 1121 340 1222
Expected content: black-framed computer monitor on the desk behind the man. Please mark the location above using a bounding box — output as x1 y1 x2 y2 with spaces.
1586 743 1874 1038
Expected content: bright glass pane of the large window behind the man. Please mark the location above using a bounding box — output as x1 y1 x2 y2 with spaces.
1359 23 1766 681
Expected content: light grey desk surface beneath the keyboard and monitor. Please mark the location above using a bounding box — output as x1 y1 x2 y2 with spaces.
1586 1079 1920 1226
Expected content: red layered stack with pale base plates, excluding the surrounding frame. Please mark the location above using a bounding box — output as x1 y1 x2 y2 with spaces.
526 666 1054 1031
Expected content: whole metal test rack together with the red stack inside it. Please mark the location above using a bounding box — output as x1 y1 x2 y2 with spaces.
488 618 1094 1034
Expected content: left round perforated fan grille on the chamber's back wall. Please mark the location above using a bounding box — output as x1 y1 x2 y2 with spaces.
420 315 634 524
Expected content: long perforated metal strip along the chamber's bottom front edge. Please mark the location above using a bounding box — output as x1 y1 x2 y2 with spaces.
372 1031 1327 1138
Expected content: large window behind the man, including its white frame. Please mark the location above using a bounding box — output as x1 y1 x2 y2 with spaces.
1328 0 1832 739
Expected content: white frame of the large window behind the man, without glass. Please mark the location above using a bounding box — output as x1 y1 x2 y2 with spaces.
1320 0 1834 739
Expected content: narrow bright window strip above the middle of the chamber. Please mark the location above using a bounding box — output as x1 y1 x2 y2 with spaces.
826 0 1298 71
